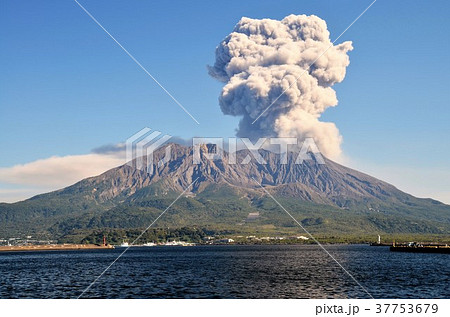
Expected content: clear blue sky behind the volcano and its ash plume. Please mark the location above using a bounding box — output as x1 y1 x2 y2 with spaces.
0 0 450 202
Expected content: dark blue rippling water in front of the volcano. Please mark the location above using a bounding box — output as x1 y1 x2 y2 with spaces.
0 245 450 298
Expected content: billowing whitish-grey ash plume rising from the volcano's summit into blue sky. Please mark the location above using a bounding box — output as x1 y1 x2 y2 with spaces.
209 15 353 158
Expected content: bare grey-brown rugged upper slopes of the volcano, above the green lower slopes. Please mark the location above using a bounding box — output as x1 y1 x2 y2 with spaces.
0 144 450 233
